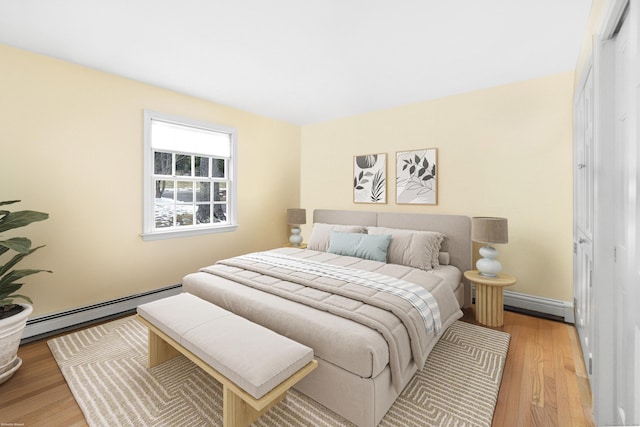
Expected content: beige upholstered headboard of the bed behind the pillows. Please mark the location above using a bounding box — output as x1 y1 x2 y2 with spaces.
313 209 472 306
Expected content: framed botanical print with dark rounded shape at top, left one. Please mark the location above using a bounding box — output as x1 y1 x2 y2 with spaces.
353 154 387 203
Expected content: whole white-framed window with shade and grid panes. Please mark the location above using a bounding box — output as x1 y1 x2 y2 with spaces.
142 111 237 240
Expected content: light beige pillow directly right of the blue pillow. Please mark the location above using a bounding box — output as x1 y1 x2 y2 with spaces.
367 227 445 270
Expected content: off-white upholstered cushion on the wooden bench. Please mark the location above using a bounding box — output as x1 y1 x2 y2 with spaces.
138 293 313 399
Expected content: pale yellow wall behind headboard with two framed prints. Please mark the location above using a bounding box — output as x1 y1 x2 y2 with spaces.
301 72 574 301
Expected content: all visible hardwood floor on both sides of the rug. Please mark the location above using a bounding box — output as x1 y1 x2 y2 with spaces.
0 308 594 427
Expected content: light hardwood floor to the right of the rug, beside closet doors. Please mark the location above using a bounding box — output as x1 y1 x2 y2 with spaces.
464 310 595 427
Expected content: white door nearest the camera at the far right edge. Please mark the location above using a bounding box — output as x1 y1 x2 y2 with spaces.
612 1 640 425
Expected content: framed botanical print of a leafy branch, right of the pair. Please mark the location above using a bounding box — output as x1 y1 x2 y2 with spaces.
396 148 438 205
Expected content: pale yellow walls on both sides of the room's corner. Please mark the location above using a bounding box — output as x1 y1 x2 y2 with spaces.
0 41 573 316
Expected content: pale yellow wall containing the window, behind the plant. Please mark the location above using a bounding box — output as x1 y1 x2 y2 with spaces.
0 45 300 316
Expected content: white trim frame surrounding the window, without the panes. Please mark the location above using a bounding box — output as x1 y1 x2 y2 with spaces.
141 110 238 241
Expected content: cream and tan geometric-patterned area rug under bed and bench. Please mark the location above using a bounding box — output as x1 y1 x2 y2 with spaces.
48 317 510 427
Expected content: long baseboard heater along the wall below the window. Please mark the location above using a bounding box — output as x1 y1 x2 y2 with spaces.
21 284 182 344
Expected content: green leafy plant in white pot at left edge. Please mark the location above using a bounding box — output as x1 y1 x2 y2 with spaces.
0 200 51 384
